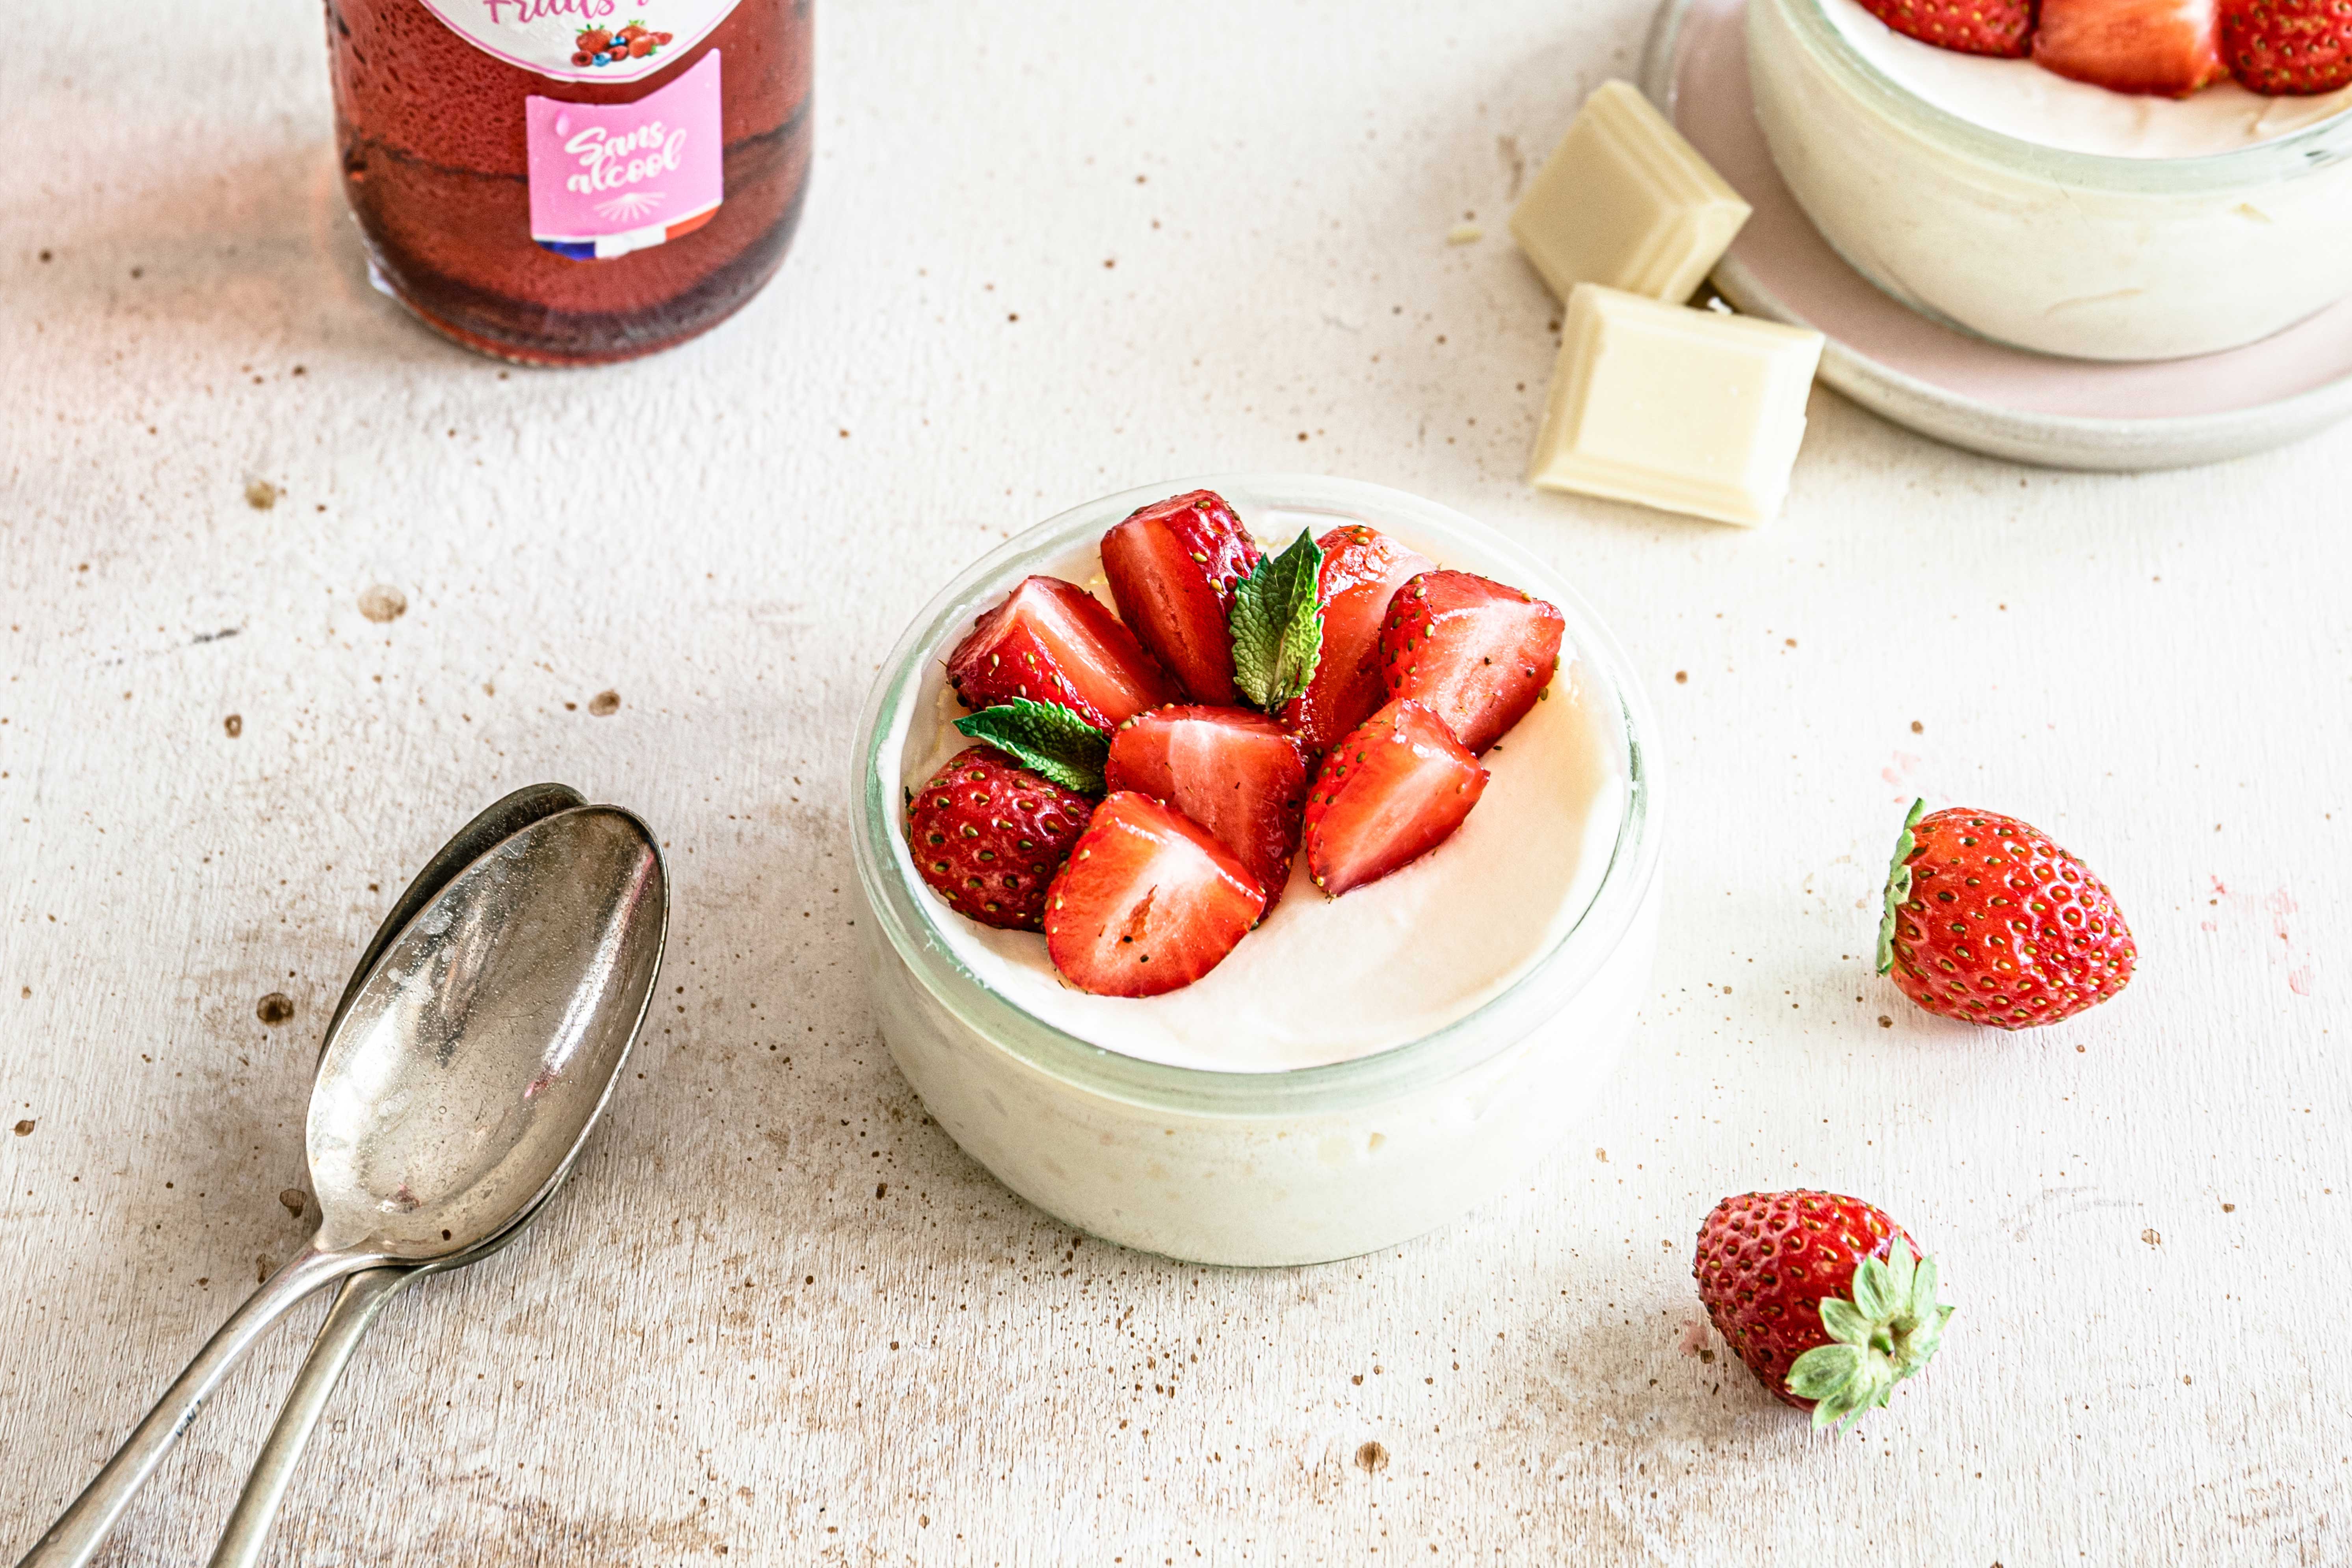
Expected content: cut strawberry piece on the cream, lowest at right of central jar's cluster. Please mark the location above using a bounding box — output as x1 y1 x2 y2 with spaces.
1305 698 1486 898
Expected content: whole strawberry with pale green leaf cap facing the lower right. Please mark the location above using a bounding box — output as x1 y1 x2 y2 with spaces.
1691 1192 1952 1427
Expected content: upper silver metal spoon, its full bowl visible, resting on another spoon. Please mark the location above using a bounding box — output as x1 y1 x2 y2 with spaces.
19 806 668 1568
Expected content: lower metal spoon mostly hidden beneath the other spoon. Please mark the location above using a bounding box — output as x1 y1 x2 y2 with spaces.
212 783 586 1568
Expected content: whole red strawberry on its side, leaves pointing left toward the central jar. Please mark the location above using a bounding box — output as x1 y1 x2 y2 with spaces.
1879 802 2138 1030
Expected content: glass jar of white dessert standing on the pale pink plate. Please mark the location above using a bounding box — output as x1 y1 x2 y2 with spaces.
1748 0 2352 360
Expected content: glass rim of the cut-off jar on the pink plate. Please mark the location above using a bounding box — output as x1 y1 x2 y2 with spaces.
1768 0 2352 195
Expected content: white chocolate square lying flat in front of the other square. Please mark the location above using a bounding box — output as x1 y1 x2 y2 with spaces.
1526 285 1823 526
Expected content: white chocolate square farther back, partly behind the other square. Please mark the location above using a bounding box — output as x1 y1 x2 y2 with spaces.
1510 82 1750 301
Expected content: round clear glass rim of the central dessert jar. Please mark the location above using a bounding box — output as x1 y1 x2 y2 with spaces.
852 472 1658 1117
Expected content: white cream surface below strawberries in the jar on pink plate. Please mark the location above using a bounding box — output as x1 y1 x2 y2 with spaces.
1820 0 2352 158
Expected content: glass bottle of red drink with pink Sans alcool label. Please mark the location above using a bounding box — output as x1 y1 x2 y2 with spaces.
327 0 811 365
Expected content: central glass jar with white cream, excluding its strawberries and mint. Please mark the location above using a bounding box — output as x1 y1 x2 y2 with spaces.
854 475 1658 1265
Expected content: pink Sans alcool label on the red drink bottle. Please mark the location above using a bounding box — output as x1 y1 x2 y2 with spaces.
522 49 727 261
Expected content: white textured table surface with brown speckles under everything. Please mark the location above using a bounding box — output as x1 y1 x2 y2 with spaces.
0 0 2352 1568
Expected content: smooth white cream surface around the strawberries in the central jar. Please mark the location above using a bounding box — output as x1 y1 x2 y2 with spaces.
913 538 1625 1072
